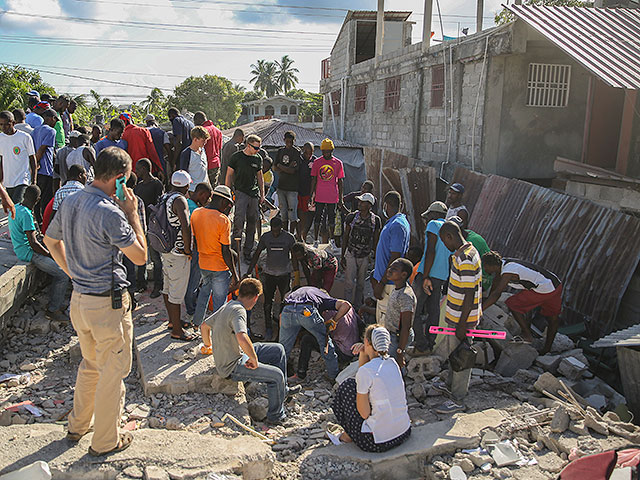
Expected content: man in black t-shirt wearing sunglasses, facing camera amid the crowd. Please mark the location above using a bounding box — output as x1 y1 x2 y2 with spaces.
225 135 264 262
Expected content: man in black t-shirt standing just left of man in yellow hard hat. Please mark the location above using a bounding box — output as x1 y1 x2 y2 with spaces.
273 131 302 233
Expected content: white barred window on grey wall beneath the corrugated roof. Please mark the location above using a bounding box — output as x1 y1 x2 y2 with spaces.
527 63 571 107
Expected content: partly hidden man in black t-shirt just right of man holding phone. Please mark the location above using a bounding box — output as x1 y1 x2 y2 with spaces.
133 158 164 298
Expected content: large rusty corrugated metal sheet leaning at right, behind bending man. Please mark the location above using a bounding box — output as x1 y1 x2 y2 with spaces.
454 169 640 338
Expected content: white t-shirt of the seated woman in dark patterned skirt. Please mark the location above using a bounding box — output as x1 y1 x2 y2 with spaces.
356 357 411 443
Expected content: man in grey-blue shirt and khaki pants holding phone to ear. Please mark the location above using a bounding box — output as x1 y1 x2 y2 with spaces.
44 147 147 456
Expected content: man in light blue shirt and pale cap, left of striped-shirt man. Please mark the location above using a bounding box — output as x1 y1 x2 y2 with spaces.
413 202 452 354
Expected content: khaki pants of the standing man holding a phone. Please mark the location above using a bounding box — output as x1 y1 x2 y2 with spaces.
69 290 133 452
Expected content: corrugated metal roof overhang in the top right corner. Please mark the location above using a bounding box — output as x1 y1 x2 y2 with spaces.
507 5 640 90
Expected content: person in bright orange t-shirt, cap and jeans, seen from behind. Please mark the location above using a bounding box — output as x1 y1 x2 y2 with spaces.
191 185 238 327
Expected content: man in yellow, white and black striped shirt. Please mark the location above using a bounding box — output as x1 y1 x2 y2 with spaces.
433 221 482 413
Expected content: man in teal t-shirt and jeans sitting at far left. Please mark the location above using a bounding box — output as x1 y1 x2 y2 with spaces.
9 185 69 321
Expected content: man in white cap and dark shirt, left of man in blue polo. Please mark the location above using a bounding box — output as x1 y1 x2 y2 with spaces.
340 193 382 309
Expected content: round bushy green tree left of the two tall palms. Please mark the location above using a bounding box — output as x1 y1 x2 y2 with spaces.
169 75 243 128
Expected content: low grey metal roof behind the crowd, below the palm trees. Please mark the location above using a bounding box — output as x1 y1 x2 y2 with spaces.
222 118 362 149
